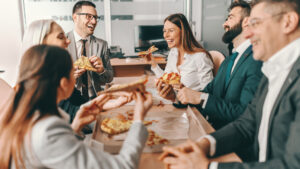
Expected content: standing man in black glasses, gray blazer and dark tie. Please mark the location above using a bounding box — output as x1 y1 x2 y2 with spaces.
67 1 113 100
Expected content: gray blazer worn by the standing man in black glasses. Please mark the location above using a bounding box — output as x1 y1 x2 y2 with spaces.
67 31 113 93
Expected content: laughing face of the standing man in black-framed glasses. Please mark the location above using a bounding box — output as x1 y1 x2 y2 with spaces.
73 6 97 38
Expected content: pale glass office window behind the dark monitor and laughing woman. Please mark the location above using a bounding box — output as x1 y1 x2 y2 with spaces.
110 0 185 55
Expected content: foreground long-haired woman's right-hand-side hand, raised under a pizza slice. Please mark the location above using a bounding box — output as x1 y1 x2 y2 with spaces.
133 92 153 121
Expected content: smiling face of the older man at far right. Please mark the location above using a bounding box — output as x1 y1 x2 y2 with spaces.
246 2 286 61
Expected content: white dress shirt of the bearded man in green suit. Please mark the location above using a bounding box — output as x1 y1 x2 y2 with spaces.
200 39 251 109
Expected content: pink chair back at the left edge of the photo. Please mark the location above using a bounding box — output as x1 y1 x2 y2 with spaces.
0 78 14 110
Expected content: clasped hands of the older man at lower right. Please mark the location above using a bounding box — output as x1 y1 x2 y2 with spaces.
163 141 209 169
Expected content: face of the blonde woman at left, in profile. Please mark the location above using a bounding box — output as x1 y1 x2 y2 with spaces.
43 22 70 48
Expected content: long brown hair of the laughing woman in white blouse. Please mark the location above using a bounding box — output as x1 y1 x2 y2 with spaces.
164 13 212 60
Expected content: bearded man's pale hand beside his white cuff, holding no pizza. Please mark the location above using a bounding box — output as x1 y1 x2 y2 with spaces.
177 87 201 104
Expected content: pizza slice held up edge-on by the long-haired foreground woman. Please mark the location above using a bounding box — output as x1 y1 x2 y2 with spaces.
98 76 148 95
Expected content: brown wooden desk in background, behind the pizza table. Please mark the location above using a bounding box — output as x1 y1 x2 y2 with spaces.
110 58 166 77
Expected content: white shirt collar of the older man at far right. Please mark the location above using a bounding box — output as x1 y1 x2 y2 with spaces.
261 38 300 77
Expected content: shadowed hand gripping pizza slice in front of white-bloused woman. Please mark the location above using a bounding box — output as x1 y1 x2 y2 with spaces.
155 80 176 102
